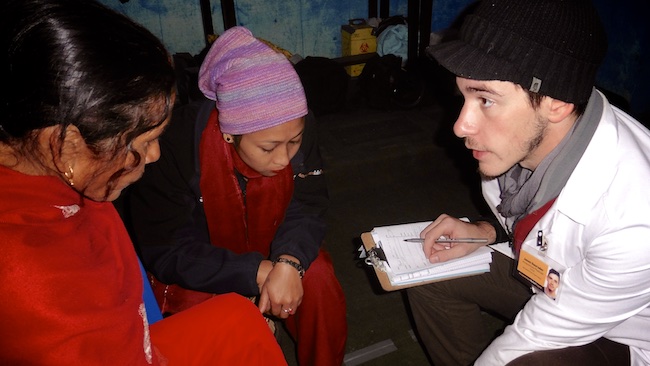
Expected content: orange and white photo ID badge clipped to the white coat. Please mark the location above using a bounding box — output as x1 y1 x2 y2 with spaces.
517 230 565 301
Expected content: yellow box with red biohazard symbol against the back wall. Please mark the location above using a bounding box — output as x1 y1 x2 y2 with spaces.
341 19 377 76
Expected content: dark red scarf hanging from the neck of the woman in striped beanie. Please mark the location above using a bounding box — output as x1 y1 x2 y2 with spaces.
152 110 293 314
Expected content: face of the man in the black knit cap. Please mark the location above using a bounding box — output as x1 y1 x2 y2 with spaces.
454 77 548 177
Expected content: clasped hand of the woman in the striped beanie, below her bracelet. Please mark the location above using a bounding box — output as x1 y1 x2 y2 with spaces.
258 255 304 319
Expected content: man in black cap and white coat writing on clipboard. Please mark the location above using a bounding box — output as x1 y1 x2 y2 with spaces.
408 0 650 366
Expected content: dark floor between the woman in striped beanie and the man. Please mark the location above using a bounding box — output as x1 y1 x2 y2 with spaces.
280 66 498 366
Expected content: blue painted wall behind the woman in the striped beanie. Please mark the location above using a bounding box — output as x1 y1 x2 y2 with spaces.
100 0 407 57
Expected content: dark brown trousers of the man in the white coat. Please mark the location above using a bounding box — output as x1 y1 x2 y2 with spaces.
407 252 630 366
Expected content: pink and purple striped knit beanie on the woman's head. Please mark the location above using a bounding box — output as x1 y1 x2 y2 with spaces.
199 27 307 135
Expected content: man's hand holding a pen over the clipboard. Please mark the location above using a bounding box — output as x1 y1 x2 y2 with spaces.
420 214 496 263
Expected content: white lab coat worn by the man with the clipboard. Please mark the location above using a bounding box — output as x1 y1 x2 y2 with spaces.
476 90 650 365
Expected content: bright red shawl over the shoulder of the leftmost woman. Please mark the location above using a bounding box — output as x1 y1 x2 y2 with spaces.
0 166 155 365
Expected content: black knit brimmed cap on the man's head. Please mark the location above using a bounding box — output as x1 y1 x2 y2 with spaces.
428 0 607 104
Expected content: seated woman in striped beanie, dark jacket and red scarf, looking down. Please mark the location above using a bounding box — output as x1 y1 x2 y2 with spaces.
118 27 347 366
